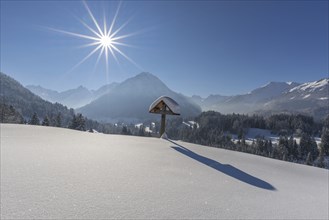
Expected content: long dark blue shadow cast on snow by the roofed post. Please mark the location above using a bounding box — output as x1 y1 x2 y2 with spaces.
167 139 276 191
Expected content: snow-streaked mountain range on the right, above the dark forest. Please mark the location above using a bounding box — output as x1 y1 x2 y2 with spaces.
192 79 329 119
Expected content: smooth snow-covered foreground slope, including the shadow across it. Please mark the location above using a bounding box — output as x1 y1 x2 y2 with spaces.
1 124 329 219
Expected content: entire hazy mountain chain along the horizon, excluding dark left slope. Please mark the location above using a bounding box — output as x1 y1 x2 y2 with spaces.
27 73 329 120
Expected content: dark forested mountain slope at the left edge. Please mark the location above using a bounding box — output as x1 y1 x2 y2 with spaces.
0 72 73 125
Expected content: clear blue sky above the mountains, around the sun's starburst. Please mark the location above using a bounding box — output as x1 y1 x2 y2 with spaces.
1 0 328 97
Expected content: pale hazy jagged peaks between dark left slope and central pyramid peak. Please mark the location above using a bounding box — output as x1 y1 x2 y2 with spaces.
26 83 117 108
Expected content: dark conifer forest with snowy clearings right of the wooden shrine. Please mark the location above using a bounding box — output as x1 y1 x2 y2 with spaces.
167 111 329 167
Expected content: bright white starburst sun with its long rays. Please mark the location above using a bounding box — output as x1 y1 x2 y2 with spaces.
49 1 142 75
